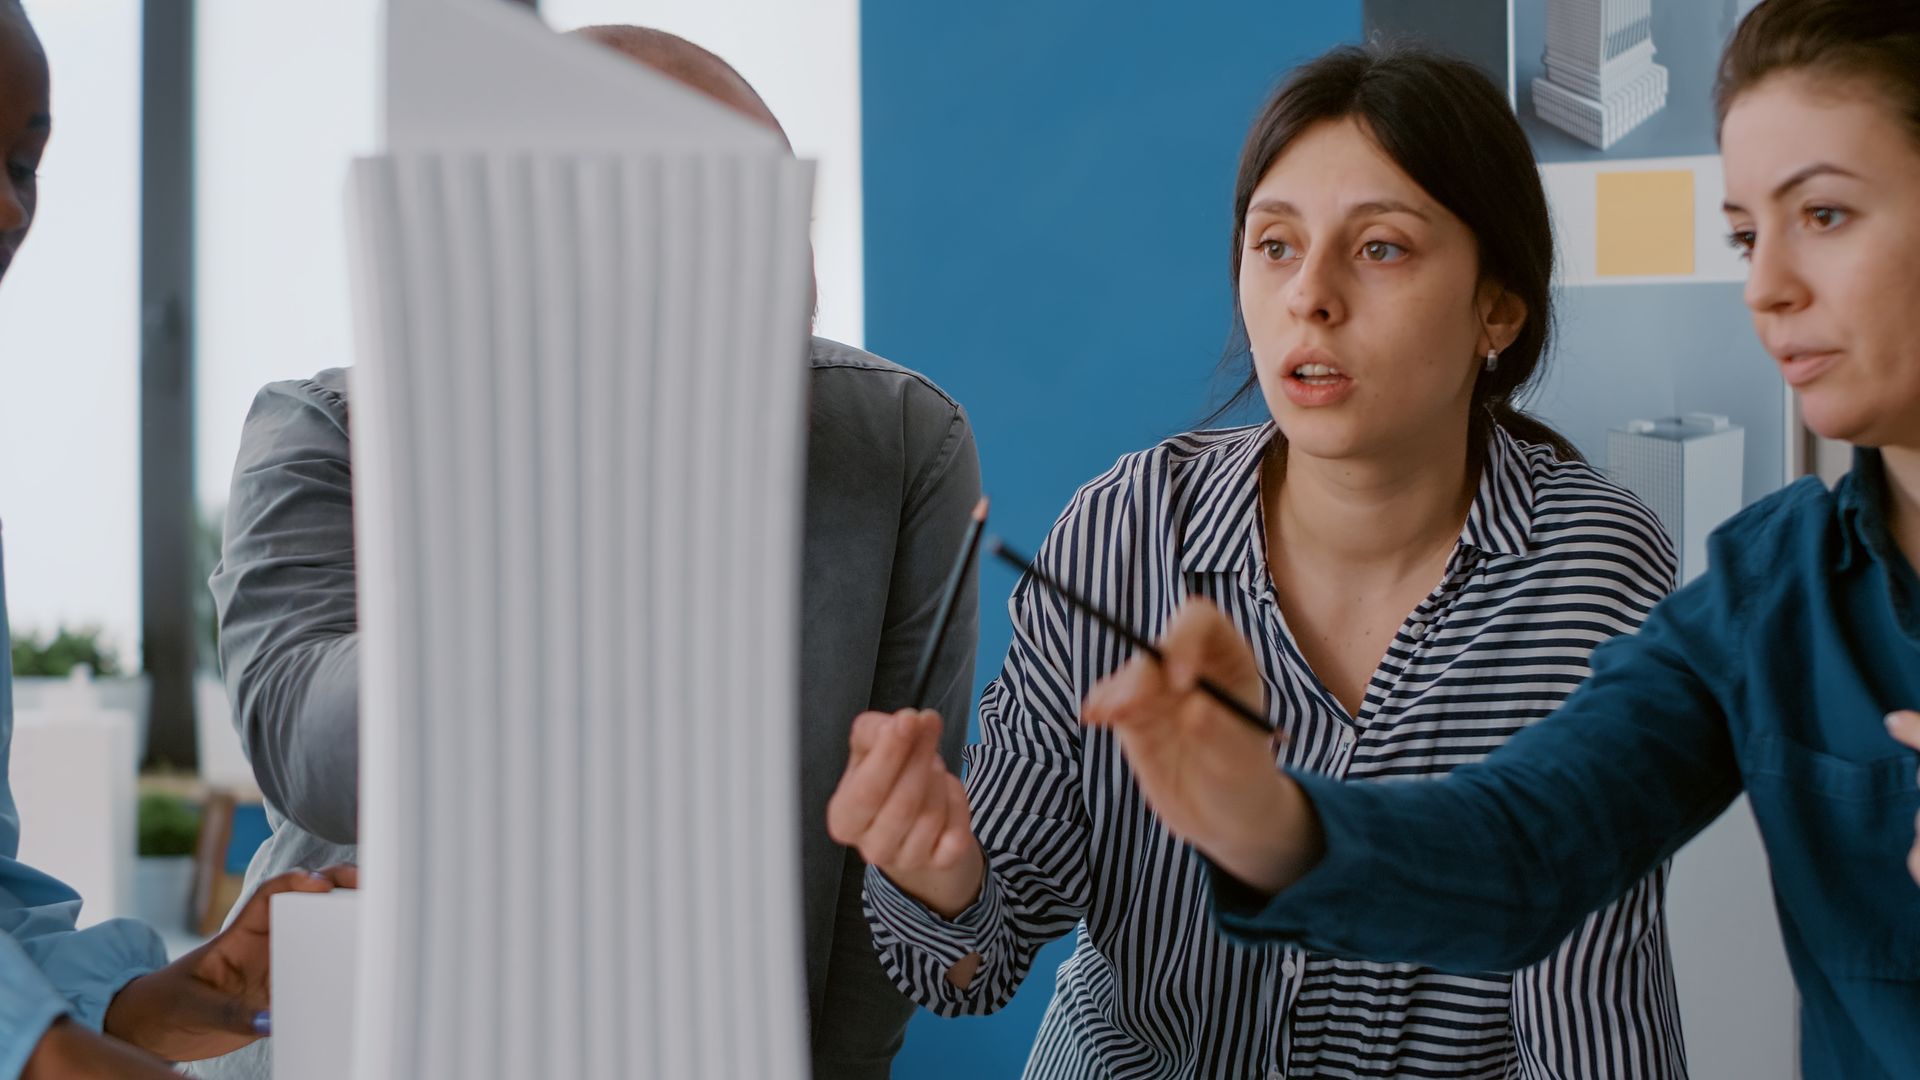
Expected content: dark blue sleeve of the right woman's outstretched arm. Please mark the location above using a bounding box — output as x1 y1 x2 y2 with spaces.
1212 573 1741 972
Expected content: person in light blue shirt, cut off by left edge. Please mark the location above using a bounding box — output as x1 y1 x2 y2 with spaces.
0 0 355 1080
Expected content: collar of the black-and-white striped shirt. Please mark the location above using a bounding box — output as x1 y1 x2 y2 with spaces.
1181 421 1534 573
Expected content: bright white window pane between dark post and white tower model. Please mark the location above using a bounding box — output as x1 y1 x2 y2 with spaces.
194 0 382 515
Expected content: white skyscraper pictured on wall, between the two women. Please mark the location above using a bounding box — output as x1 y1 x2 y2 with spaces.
1607 413 1747 584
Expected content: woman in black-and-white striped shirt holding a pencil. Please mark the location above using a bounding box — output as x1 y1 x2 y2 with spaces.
829 50 1686 1078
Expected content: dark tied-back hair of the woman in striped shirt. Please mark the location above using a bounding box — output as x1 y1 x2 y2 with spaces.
1212 46 1580 461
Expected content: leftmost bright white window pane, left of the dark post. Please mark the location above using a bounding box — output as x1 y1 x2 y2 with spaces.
0 0 140 665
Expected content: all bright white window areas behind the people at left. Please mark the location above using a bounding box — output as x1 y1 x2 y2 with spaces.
0 0 866 663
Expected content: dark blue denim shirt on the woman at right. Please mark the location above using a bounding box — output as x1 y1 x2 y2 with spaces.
1213 450 1920 1080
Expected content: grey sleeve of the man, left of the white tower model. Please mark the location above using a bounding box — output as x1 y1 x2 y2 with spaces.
207 373 359 844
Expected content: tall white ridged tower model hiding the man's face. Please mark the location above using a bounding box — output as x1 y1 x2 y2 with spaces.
312 0 812 1080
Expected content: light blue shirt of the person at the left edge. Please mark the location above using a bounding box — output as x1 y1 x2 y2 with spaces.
0 526 167 1080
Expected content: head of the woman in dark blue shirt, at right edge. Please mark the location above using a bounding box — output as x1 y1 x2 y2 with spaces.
1715 0 1920 450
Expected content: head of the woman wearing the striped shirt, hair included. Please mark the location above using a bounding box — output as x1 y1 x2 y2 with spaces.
1233 48 1576 459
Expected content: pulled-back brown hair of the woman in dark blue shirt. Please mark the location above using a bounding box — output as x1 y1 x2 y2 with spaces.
1713 0 1920 142
